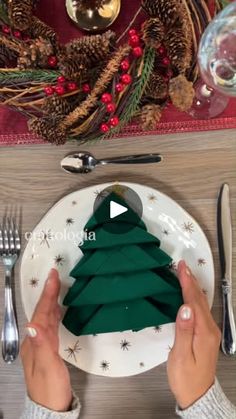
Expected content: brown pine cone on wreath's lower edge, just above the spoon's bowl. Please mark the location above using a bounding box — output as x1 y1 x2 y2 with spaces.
28 118 66 145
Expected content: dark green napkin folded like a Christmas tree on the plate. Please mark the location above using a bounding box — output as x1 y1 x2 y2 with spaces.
63 193 183 336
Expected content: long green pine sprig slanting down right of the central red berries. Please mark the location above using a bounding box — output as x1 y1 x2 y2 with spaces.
103 48 156 139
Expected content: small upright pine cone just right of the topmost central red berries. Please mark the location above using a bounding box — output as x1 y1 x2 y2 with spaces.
143 17 164 48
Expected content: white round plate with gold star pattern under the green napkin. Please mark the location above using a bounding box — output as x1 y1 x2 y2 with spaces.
21 183 214 377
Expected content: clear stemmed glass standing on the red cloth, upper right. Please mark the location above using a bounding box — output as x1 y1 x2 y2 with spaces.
189 1 236 119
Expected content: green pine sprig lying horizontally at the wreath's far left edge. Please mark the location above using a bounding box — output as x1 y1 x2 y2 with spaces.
0 69 60 86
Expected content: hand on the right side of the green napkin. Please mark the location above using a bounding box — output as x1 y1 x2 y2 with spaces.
167 261 221 409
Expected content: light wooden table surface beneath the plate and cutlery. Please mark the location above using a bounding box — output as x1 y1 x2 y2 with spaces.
0 130 236 419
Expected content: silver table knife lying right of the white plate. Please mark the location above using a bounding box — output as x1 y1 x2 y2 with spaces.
217 183 236 355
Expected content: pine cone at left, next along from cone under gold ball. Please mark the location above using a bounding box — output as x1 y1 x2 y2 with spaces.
17 37 53 70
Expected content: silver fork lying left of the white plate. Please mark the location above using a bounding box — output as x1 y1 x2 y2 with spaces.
0 217 21 364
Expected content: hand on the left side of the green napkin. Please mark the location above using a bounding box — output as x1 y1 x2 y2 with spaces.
21 269 72 412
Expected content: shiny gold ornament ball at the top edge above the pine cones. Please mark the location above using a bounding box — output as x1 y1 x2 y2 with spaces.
66 0 121 32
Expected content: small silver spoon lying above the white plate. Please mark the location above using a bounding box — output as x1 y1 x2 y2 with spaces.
61 151 163 173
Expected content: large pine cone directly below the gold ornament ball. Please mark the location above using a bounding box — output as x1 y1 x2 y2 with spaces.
66 31 116 67
